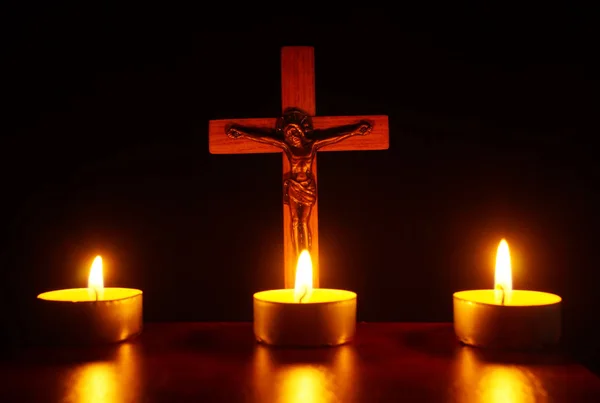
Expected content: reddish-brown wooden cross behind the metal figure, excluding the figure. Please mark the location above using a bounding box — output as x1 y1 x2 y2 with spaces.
208 46 389 288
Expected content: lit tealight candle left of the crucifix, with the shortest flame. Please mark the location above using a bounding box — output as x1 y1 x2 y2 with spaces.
38 256 143 344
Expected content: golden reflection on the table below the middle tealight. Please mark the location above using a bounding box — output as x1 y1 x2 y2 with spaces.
253 345 359 403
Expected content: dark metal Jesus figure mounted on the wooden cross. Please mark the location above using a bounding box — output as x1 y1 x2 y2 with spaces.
226 108 372 256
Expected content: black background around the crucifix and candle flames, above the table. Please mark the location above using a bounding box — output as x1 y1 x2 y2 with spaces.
0 5 600 367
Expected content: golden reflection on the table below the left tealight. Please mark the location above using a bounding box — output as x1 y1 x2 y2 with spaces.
65 343 141 403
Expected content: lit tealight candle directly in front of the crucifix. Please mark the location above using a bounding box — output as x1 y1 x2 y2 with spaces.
254 250 356 347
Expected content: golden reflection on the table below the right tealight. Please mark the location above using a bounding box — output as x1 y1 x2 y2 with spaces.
454 347 548 403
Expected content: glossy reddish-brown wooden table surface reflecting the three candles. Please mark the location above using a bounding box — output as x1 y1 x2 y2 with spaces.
0 323 600 403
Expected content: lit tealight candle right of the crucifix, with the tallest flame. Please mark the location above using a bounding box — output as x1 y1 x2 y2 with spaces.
454 240 561 349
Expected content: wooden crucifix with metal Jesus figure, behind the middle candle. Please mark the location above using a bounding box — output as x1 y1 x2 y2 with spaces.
208 46 389 288
